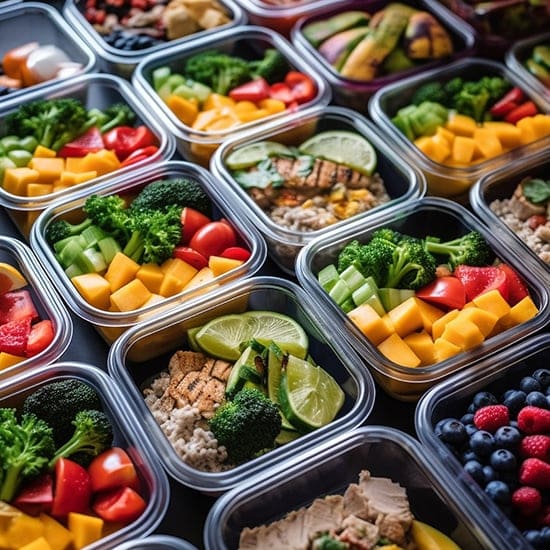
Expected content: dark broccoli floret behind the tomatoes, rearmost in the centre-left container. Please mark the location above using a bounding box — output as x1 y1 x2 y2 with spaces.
131 178 212 216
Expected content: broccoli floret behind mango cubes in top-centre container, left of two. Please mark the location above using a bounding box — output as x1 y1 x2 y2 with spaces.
184 50 251 95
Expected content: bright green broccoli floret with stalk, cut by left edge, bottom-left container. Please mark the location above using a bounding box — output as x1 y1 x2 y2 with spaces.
0 408 55 502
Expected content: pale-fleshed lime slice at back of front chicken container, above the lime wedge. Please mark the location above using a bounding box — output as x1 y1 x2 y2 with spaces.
243 311 309 358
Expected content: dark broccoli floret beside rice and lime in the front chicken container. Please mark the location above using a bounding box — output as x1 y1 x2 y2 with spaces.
210 388 281 464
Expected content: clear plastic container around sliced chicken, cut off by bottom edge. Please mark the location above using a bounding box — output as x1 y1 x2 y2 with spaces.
203 426 494 550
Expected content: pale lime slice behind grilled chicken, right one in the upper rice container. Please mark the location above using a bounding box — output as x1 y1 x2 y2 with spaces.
299 130 376 176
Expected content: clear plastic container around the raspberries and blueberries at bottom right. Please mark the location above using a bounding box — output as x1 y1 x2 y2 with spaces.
415 333 550 550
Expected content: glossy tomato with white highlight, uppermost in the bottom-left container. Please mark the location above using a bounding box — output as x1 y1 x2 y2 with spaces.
88 447 139 493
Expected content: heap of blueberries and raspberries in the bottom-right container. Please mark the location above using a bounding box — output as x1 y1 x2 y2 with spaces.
434 368 550 548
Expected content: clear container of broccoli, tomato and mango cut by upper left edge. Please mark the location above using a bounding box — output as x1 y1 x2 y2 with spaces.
0 73 175 238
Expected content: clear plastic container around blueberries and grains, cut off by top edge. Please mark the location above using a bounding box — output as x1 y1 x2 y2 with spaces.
63 0 246 78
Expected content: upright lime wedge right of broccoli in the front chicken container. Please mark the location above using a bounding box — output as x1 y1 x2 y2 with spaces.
279 355 345 432
